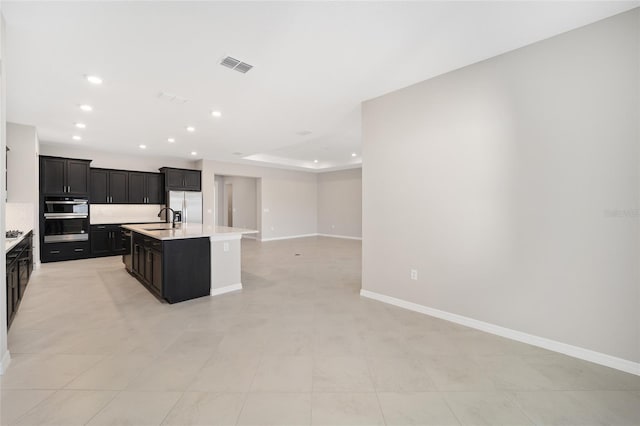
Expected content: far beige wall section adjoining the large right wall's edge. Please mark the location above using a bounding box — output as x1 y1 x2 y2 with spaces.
318 168 362 238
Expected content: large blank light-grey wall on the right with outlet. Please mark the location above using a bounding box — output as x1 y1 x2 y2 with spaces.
363 9 640 371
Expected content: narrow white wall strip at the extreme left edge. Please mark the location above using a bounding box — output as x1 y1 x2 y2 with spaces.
0 8 11 374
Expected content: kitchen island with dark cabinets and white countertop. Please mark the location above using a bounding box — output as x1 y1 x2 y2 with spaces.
122 223 258 303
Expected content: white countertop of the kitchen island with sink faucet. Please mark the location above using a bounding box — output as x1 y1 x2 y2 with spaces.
122 222 258 240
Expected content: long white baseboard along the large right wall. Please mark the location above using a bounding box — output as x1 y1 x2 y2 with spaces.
360 289 640 376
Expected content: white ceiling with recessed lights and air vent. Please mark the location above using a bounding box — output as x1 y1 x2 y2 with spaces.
3 1 639 170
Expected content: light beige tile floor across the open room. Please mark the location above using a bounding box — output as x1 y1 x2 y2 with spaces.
0 237 640 426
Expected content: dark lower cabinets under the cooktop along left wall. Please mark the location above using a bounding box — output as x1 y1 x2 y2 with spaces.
6 232 33 328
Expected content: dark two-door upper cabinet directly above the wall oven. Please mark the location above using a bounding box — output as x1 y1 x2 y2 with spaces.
40 155 91 196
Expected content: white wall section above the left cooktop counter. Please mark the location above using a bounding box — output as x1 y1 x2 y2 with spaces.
5 123 40 266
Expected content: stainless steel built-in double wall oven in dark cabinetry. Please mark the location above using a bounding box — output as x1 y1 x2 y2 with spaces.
44 197 89 243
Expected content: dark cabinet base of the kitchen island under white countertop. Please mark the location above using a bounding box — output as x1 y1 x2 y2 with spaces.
131 232 211 303
